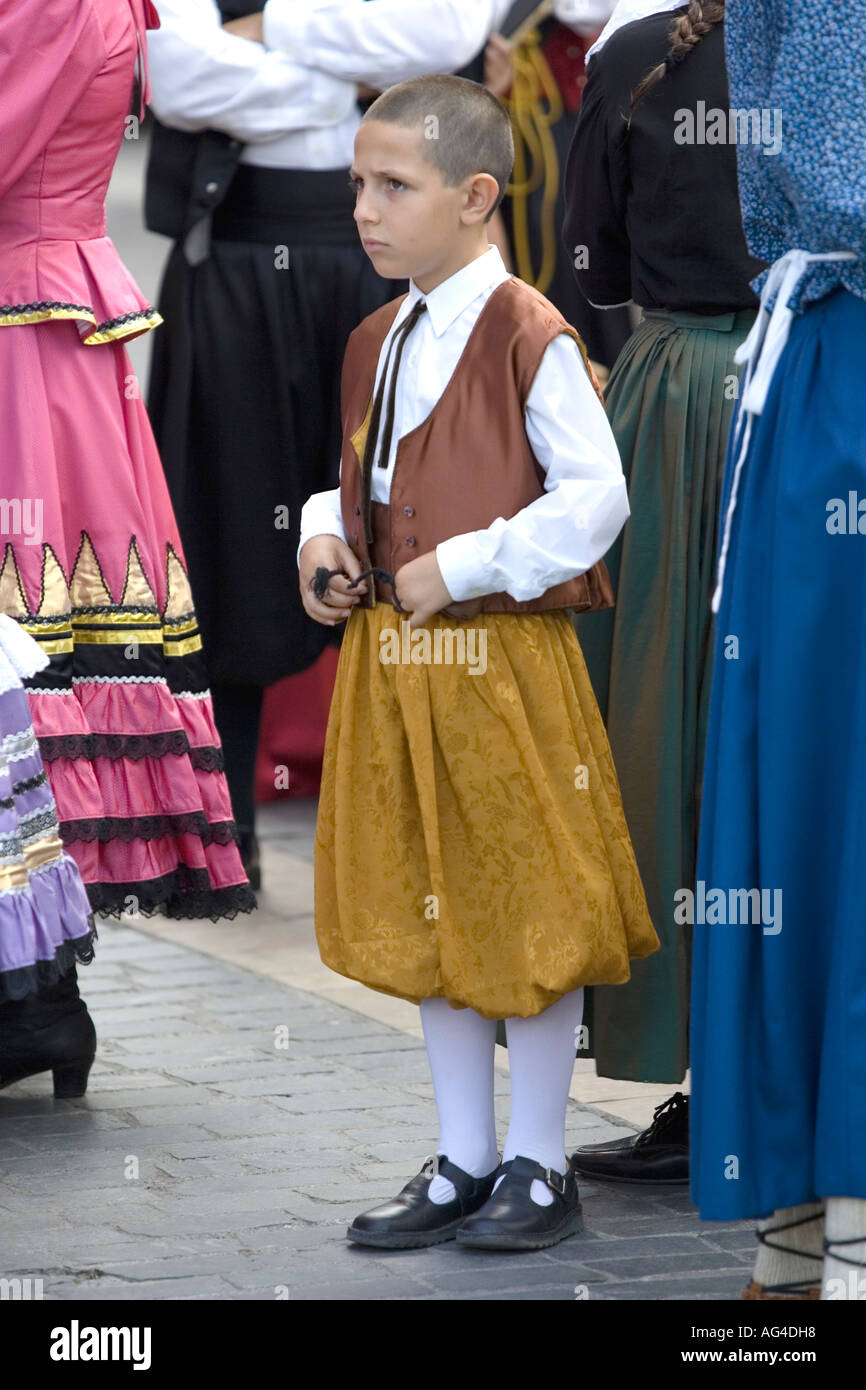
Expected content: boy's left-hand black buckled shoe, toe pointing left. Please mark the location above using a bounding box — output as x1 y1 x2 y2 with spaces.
346 1154 499 1250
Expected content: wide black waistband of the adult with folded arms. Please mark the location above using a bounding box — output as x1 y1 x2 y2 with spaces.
211 164 360 246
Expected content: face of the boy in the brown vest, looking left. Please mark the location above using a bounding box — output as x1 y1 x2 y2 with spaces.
352 120 487 293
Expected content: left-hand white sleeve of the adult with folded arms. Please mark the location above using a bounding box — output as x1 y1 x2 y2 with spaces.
147 0 357 145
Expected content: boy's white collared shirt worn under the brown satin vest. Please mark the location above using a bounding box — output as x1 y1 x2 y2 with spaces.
297 246 628 602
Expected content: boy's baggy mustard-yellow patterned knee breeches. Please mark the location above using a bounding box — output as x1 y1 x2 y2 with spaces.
316 603 659 1019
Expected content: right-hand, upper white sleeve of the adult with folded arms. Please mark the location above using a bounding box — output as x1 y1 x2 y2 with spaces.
263 0 512 88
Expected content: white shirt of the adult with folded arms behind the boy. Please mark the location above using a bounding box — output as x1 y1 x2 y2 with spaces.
147 0 509 170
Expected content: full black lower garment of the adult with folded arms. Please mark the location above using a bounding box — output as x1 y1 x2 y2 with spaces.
147 164 406 685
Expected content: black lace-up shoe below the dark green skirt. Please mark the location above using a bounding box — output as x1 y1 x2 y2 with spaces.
571 1091 688 1183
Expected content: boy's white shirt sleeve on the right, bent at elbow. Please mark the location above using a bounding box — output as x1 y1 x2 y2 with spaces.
436 334 628 602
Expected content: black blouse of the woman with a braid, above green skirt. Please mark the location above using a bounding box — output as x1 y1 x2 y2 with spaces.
563 6 756 314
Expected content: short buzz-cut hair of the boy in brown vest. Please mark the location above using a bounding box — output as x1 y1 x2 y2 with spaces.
364 74 514 221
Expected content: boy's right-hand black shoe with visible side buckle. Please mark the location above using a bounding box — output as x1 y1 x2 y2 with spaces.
457 1154 584 1250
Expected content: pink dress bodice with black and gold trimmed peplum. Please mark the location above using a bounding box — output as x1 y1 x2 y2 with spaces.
0 0 161 346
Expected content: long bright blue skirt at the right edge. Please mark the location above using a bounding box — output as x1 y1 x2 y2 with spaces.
692 291 866 1220
